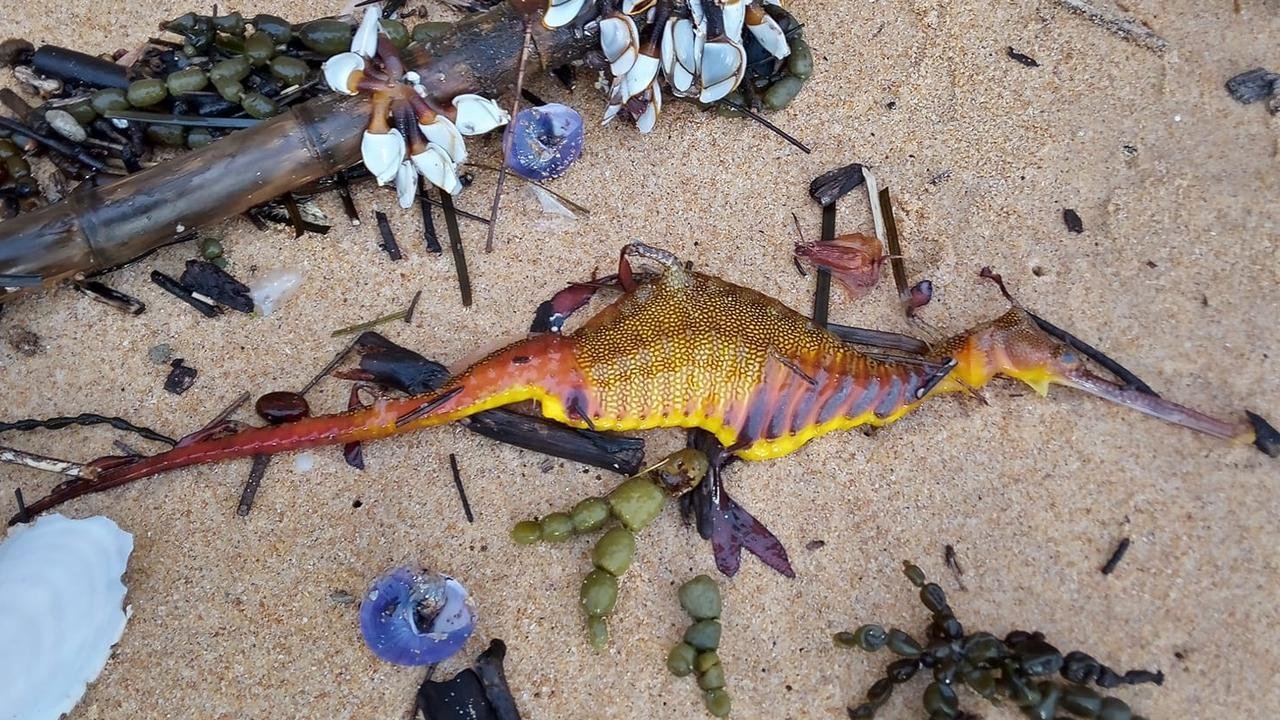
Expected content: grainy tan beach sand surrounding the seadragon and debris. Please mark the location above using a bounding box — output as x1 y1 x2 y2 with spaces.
0 0 1280 720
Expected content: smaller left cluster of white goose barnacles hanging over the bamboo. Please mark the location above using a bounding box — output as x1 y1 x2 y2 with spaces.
324 5 509 208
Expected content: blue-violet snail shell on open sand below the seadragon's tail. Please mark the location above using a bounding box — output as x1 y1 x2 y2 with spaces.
360 565 476 665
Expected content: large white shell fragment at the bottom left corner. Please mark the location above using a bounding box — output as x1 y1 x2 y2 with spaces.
0 514 133 720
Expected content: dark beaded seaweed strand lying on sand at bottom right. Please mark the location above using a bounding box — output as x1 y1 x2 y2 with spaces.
833 562 1165 720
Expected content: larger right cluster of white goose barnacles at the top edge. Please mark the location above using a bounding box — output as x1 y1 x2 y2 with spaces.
543 0 791 132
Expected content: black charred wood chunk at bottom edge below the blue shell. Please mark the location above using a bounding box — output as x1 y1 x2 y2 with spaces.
416 639 520 720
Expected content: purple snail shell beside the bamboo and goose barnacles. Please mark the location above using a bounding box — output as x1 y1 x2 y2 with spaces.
507 102 582 181
